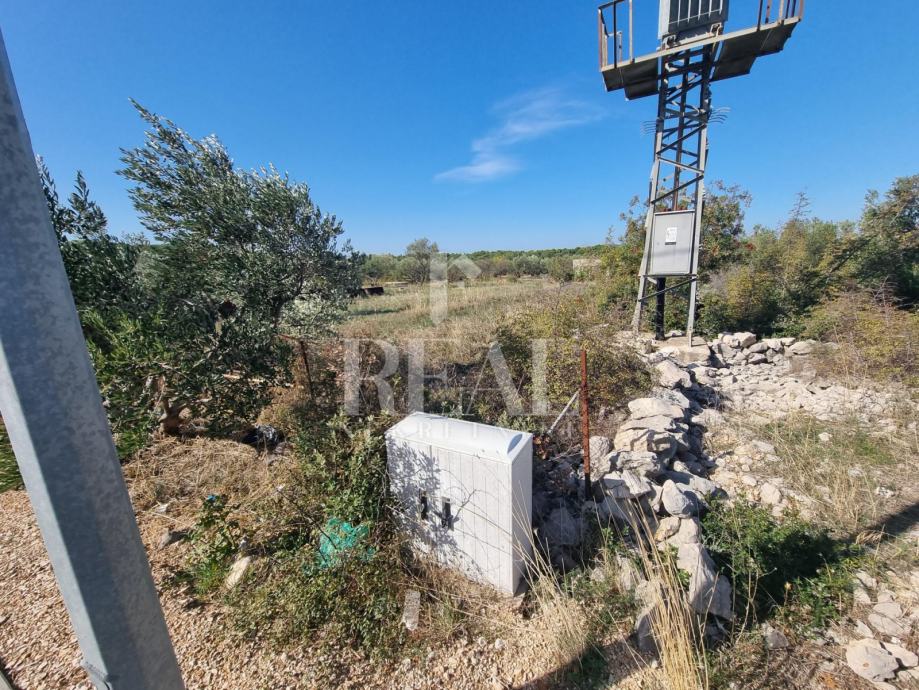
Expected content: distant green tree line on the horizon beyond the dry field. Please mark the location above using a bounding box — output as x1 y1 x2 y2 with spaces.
361 238 605 284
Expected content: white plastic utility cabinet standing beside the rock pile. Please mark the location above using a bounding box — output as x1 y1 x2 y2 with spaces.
386 412 533 594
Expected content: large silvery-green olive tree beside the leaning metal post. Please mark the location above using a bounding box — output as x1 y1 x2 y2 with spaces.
43 104 358 447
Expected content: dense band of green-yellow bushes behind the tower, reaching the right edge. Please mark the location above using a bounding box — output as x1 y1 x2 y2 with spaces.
604 175 919 335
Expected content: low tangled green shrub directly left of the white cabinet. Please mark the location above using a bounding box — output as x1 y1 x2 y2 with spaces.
230 414 405 654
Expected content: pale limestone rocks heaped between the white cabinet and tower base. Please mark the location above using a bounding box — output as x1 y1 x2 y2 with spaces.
534 333 916 656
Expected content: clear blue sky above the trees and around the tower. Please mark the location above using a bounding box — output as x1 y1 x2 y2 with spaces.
0 0 919 252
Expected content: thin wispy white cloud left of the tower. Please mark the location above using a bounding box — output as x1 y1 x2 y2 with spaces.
434 87 602 182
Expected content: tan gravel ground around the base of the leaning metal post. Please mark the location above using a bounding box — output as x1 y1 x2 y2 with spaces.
0 491 651 690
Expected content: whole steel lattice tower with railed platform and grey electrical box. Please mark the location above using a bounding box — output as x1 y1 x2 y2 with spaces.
597 0 804 343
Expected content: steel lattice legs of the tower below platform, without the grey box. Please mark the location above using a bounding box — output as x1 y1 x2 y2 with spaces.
632 45 713 338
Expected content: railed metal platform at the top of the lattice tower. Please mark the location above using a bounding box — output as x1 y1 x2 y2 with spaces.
597 0 804 100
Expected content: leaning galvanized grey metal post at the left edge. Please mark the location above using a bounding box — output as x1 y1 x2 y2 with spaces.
0 28 183 690
